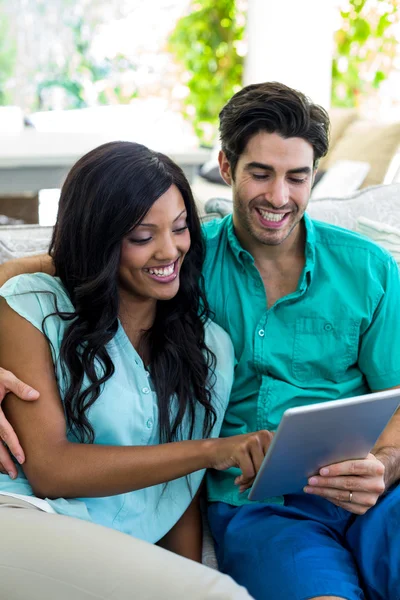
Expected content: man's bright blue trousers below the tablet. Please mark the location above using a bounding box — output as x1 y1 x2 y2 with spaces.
208 486 400 600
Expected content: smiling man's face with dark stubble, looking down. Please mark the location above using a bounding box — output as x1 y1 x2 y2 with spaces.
219 132 314 246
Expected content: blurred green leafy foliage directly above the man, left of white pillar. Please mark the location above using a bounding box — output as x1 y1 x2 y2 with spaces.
169 0 244 144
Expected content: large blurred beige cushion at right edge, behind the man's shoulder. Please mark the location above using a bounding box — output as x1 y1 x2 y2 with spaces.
323 121 400 188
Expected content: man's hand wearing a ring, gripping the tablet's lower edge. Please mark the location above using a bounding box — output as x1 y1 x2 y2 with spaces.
304 454 385 515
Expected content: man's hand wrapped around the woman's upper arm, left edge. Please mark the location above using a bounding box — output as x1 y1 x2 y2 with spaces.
0 367 39 479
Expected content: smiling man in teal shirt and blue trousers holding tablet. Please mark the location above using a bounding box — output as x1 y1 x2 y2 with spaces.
0 83 400 600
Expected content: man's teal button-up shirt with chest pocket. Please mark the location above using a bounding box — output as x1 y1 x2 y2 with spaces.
204 215 400 505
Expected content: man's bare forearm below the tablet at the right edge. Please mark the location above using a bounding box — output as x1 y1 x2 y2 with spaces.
372 410 400 489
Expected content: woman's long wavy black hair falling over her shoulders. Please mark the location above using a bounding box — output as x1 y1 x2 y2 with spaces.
50 142 216 442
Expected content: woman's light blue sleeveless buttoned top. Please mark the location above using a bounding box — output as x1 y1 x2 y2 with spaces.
0 273 234 543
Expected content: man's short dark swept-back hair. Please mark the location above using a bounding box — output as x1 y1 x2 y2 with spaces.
219 81 330 175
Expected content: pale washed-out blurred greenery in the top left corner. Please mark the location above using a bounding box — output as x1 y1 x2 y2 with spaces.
0 0 137 113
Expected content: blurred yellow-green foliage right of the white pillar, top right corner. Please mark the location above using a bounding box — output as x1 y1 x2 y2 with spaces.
332 0 400 107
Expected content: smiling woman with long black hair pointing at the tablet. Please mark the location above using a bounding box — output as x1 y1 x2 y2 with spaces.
0 142 269 598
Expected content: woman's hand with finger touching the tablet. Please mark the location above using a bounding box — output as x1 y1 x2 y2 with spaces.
209 430 274 492
